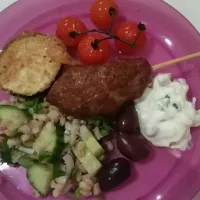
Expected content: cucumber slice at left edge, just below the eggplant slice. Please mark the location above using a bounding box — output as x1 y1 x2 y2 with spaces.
0 105 29 136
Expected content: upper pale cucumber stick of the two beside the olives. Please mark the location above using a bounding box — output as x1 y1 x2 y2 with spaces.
80 125 104 158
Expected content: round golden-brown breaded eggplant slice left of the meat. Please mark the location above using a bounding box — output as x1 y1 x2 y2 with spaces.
0 32 73 96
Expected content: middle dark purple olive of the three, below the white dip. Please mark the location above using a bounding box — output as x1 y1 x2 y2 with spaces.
116 132 150 162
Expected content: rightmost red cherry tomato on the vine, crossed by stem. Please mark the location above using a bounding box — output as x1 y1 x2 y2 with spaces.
116 21 147 54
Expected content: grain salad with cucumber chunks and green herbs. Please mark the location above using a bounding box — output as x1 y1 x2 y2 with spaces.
0 96 113 197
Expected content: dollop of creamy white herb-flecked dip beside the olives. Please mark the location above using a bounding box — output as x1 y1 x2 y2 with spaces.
136 74 200 150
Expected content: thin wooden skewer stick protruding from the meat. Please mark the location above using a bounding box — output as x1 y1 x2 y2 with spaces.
152 52 200 70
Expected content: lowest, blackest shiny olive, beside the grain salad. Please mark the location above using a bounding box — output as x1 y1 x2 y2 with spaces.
99 158 131 192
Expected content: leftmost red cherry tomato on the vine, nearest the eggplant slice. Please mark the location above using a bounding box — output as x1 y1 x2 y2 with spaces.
56 17 87 46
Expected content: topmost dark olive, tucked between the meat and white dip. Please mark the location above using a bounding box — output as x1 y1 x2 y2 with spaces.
116 101 139 134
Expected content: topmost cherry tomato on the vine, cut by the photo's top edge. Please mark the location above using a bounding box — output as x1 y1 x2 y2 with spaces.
90 0 118 29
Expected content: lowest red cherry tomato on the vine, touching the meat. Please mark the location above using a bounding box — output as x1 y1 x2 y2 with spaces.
78 33 110 65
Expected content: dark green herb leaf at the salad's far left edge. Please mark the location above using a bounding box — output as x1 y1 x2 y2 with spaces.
0 138 13 164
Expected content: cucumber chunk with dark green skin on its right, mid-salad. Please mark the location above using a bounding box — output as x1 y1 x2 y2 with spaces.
33 123 64 163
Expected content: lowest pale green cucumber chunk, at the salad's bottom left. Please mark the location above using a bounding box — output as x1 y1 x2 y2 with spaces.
27 164 53 197
